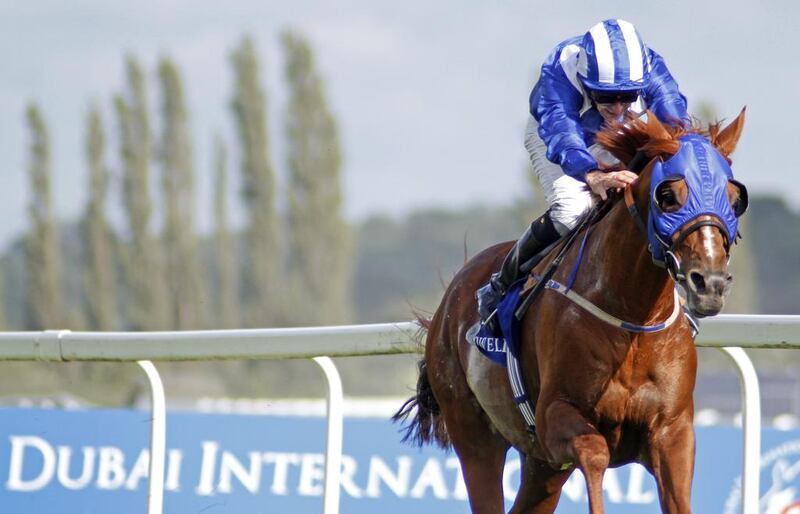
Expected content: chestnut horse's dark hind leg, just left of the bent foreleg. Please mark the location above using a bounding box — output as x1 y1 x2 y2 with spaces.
509 455 572 514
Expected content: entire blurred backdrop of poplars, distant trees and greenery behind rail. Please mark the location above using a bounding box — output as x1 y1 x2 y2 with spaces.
0 31 800 405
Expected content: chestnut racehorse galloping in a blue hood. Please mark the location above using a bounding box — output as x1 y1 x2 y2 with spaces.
395 110 747 514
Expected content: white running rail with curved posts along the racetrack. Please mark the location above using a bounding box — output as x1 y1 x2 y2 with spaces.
0 315 800 514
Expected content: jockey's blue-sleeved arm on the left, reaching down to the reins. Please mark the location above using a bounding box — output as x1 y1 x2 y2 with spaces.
530 63 598 180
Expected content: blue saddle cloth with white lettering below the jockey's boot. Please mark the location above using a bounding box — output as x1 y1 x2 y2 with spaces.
468 277 528 367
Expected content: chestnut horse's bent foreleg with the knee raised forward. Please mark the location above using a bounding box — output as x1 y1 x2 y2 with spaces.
542 400 611 514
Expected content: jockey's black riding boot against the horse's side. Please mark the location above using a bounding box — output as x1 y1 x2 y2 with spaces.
475 211 561 321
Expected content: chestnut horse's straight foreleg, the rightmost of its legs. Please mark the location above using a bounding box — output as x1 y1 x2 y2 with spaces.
649 412 695 514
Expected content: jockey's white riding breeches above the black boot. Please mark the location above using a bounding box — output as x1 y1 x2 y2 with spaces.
525 116 618 235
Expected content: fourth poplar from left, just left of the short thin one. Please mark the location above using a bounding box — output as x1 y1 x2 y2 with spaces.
158 57 207 329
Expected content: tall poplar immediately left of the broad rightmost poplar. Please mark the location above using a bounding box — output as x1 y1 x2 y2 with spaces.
231 37 282 327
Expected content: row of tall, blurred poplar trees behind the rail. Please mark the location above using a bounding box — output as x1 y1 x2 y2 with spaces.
16 31 353 330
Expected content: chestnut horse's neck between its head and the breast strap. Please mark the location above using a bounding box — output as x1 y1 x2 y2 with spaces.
577 202 673 324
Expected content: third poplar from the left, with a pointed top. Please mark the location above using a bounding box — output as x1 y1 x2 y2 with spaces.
114 57 167 330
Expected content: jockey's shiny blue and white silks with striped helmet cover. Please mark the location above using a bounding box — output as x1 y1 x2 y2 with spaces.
530 20 689 180
